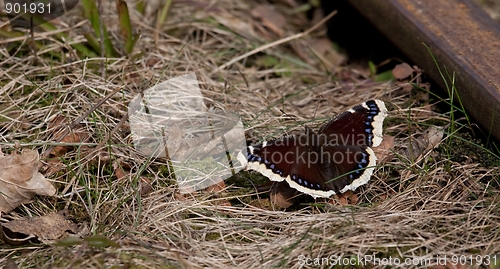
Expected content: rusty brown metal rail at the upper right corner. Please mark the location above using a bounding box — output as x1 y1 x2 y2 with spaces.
347 0 500 140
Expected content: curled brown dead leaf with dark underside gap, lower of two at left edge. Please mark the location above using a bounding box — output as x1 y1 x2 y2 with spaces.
0 212 78 245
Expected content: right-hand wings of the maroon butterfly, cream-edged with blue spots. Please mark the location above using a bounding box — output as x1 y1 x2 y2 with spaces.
318 100 388 193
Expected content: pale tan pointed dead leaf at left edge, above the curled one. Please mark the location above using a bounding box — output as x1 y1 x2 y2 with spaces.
0 150 56 213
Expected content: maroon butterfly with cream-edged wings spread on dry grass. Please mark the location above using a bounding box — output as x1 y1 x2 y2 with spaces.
244 100 388 198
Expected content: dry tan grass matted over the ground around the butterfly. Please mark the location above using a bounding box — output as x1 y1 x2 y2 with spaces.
0 1 500 268
